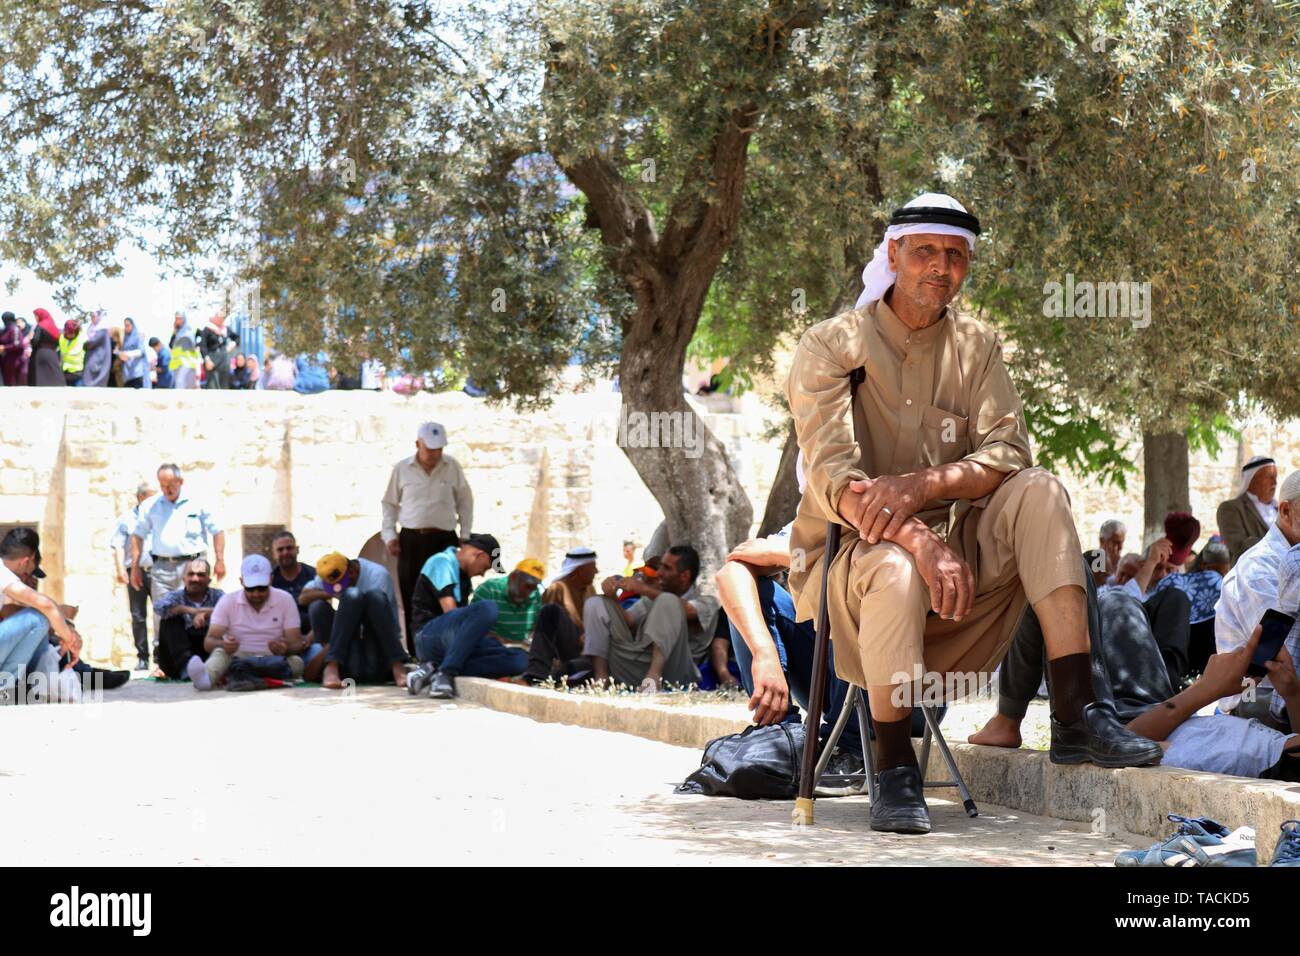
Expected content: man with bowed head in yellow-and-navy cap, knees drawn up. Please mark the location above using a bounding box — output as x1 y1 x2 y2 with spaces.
298 551 411 691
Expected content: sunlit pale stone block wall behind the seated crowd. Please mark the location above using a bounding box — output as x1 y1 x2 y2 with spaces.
0 384 1300 666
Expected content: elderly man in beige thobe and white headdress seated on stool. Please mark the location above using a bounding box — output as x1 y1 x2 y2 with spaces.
788 194 1161 832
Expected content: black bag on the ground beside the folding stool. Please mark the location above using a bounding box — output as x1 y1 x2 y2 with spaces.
673 722 803 800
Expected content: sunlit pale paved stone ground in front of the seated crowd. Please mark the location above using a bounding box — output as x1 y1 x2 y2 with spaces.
0 680 1133 865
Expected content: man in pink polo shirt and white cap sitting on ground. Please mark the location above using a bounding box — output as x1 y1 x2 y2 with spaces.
185 554 307 691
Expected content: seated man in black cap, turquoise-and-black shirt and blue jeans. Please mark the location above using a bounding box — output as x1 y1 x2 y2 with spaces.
407 535 525 700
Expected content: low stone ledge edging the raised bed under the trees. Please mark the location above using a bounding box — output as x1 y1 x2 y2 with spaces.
456 678 1300 865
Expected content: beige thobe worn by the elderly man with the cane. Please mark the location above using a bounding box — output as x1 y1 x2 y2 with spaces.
787 300 1084 687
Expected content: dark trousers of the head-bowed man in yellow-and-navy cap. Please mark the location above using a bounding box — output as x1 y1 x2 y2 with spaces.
308 587 410 684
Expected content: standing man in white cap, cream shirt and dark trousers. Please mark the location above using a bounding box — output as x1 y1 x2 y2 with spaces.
381 421 475 648
